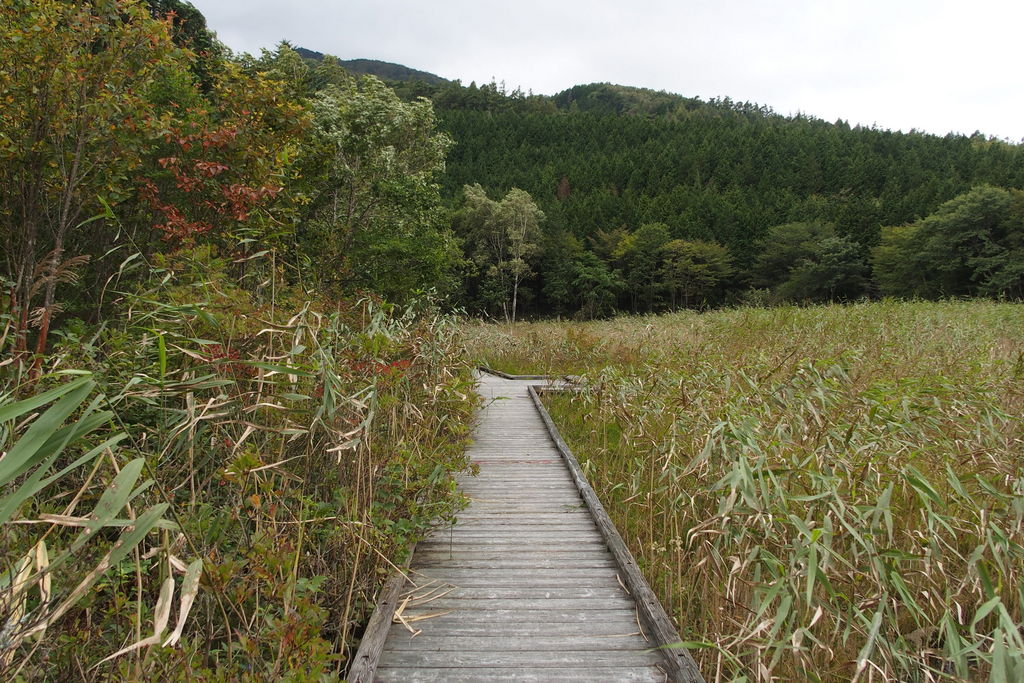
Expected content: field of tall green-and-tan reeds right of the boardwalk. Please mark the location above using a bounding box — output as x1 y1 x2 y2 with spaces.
467 301 1024 681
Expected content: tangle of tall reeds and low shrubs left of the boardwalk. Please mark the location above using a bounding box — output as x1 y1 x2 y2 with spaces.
0 250 473 680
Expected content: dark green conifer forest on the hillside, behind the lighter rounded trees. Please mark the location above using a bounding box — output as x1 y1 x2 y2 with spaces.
418 83 1024 314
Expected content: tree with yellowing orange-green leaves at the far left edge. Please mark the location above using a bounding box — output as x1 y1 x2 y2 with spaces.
0 0 187 358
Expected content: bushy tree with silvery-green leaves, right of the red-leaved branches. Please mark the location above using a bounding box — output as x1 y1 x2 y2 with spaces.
301 77 454 299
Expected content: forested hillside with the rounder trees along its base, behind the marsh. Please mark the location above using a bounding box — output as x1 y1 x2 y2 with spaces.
385 82 1024 315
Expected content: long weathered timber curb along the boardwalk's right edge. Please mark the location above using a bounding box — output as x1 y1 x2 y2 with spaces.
529 386 705 683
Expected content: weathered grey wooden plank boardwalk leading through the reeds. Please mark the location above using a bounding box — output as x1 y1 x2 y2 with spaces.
356 375 699 683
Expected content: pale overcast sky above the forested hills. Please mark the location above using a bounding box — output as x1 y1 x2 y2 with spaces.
191 0 1024 142
